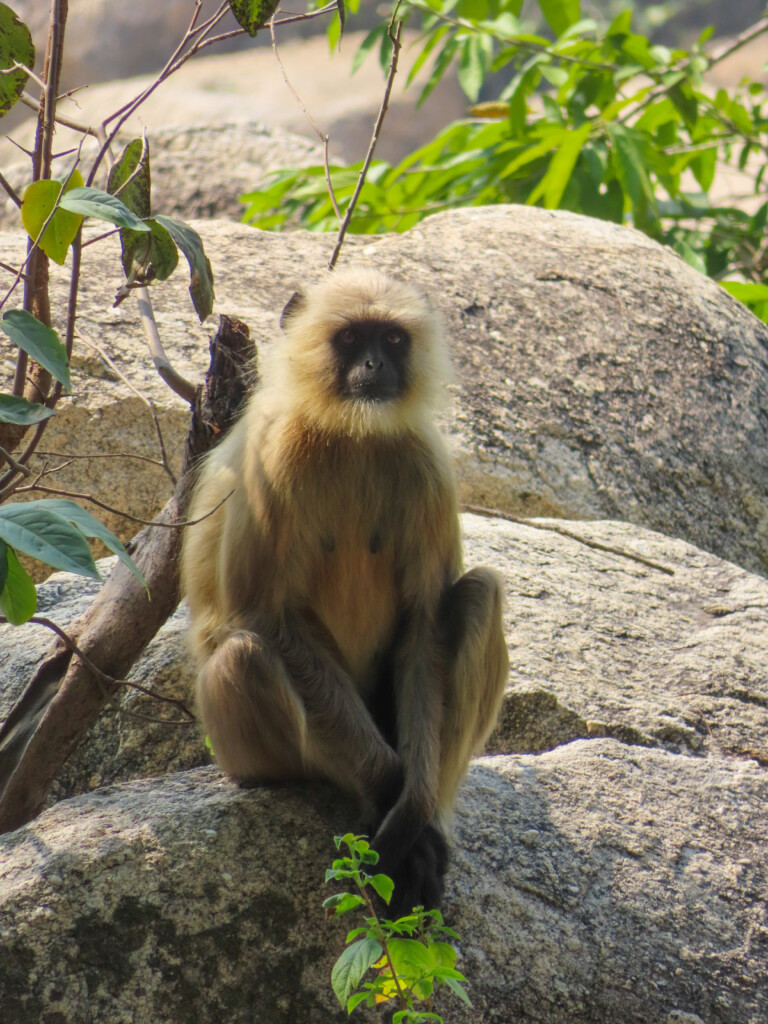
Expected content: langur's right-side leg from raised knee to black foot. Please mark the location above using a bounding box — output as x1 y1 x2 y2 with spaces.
374 568 509 913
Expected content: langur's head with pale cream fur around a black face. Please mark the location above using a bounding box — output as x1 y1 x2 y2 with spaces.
272 270 449 434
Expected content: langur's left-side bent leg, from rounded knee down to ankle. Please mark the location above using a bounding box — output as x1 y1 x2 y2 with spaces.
198 631 400 799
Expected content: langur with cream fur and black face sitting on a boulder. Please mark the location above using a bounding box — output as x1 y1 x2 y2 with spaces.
182 270 508 912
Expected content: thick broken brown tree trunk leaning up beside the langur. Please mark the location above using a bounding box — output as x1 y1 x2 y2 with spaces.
0 316 253 831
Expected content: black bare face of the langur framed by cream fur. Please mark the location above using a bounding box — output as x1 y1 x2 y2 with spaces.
331 319 411 401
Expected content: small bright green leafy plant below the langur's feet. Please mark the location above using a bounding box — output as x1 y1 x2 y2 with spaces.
323 833 471 1024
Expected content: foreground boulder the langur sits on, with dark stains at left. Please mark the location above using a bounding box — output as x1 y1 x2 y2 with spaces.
0 739 768 1024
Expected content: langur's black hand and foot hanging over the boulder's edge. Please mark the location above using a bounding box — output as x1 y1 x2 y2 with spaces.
372 808 449 918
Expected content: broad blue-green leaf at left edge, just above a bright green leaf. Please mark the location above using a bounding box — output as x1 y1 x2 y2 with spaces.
0 502 99 580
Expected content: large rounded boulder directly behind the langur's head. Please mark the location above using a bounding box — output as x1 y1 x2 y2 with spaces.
0 207 768 573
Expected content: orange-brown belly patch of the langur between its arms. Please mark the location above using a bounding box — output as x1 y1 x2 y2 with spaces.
310 535 397 690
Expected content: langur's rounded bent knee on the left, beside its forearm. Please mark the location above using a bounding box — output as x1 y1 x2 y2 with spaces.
197 632 306 781
